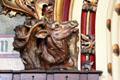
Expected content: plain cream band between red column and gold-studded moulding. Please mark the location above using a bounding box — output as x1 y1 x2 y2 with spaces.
95 0 109 80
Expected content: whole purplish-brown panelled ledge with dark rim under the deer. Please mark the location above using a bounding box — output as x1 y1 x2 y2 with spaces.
0 70 102 80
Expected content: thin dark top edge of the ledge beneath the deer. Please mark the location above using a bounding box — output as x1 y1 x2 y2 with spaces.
0 70 102 75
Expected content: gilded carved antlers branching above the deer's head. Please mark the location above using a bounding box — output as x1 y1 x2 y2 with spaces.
2 0 54 20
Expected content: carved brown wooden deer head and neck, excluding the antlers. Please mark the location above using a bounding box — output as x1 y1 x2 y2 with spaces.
14 21 78 69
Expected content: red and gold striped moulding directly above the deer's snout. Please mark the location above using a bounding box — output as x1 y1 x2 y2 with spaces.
54 0 74 22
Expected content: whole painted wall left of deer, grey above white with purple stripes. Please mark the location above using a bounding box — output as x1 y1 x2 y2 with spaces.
0 0 25 70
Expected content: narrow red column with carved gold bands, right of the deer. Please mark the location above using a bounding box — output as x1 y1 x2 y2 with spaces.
81 0 98 70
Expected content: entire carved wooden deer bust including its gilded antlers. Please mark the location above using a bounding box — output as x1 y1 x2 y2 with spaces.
2 0 78 69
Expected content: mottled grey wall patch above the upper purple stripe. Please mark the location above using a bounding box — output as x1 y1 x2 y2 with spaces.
0 3 25 34
